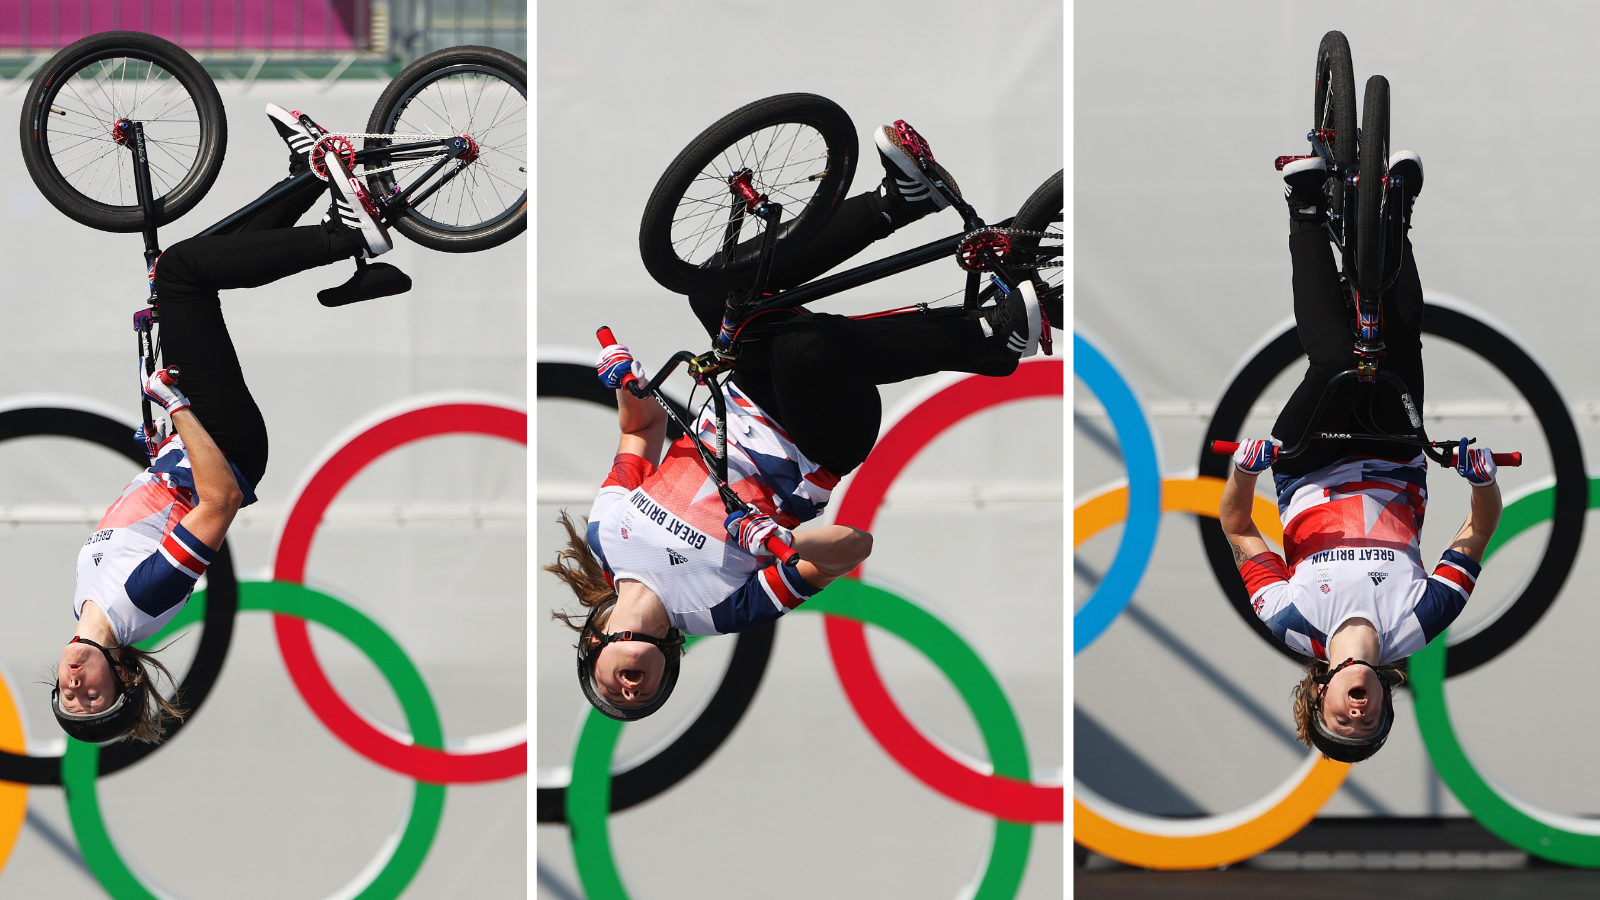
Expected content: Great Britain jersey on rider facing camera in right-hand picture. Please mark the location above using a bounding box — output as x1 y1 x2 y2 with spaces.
1240 456 1480 665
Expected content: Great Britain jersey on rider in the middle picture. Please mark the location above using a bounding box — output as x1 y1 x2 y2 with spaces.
587 384 838 634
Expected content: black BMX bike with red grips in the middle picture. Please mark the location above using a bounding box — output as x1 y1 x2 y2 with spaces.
597 93 1062 565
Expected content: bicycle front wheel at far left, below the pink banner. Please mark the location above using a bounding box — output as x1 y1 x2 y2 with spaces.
21 32 227 232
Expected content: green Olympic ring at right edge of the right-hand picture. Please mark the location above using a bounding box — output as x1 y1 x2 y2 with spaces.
1411 477 1600 868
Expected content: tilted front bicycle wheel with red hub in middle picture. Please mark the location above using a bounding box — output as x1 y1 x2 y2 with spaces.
638 93 856 293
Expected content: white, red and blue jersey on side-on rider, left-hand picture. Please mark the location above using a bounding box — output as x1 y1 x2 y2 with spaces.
72 436 256 645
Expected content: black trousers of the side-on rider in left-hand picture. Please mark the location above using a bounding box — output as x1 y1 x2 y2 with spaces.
155 179 360 487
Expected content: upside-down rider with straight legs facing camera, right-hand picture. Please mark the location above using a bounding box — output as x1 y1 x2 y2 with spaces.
1219 151 1501 762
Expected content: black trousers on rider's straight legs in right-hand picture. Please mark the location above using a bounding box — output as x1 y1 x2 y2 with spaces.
1272 229 1424 476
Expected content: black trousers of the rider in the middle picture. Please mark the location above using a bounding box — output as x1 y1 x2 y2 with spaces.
690 186 1018 476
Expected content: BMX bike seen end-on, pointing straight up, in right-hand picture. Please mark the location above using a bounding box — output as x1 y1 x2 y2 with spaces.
1211 30 1522 468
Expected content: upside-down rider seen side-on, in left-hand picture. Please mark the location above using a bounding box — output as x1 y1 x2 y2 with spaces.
51 104 411 743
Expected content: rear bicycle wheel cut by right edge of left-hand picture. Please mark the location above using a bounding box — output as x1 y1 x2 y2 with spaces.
363 46 528 253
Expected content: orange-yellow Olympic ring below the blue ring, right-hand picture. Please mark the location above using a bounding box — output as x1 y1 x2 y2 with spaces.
1072 476 1350 870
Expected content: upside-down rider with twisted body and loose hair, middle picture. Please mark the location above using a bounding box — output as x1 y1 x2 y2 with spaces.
546 122 1061 721
